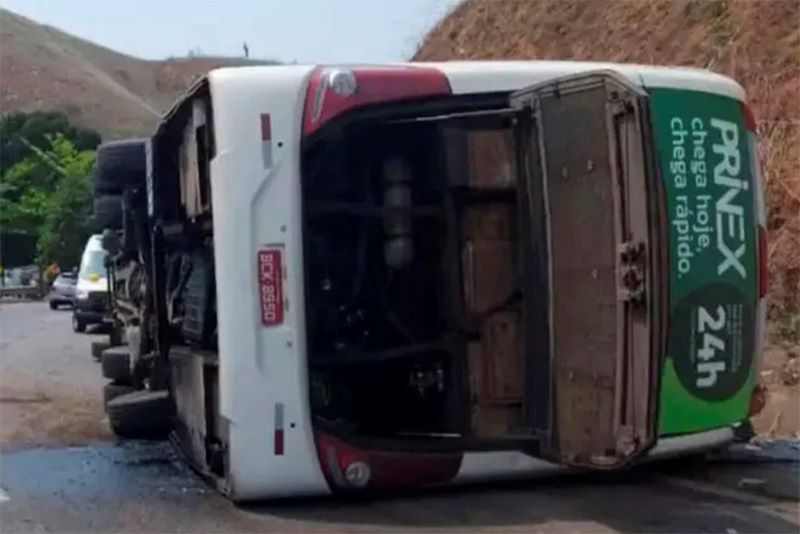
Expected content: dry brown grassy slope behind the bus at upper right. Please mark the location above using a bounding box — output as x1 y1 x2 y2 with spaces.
414 0 800 330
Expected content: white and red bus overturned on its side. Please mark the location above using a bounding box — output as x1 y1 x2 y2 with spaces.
92 61 766 500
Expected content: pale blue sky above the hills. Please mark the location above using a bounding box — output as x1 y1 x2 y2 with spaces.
0 0 459 63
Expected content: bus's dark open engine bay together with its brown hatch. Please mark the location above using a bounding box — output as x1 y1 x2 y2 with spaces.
303 68 666 488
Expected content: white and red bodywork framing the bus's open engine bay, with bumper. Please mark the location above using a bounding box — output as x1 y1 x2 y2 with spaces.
142 61 763 500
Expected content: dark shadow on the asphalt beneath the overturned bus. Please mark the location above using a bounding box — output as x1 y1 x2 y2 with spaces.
245 464 798 532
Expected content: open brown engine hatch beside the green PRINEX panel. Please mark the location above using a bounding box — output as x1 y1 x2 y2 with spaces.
511 71 661 468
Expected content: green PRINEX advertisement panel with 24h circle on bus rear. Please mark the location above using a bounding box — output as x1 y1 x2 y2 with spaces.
650 89 758 435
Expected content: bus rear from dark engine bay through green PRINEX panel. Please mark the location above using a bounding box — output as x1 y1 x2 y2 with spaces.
303 68 766 489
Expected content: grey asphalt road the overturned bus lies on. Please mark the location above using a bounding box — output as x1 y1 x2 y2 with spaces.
0 303 800 534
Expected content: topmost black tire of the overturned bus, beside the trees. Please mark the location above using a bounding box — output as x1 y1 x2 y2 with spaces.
94 139 147 195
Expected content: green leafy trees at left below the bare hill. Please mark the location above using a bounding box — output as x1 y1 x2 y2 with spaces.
0 112 100 268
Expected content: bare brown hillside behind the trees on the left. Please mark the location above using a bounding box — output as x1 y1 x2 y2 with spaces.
0 9 274 139
